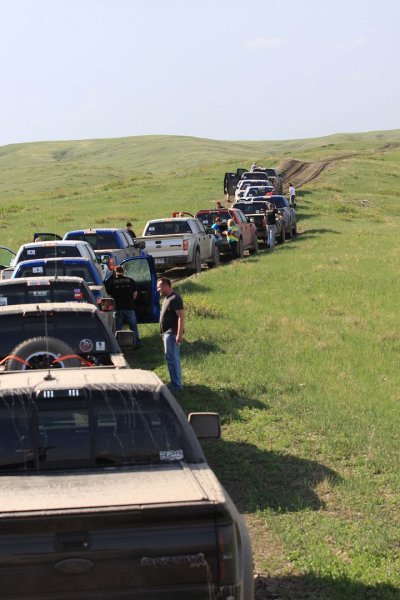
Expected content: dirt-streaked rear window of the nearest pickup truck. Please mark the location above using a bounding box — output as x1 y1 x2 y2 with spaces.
0 387 193 471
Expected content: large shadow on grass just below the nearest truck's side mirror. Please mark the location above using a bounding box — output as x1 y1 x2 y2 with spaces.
202 440 341 513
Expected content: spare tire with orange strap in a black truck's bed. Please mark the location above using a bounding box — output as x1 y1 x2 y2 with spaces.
6 337 81 371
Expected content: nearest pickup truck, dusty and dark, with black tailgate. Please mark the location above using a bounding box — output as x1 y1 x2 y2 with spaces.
0 367 254 600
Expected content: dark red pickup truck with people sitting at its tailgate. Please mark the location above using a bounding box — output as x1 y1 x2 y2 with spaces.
195 208 258 258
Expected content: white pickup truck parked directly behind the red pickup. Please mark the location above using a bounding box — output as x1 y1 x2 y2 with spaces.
136 217 219 273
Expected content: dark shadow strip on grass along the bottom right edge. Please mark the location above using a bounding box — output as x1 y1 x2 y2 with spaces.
254 573 400 600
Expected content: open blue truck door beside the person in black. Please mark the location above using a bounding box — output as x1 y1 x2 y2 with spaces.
117 256 160 323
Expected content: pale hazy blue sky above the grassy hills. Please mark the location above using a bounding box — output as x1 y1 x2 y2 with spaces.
0 0 400 146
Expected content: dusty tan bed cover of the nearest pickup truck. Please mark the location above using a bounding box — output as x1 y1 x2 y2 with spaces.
0 462 225 517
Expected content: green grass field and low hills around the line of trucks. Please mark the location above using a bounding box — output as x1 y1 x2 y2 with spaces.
0 131 400 600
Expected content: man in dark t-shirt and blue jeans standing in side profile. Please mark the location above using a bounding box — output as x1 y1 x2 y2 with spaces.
157 277 185 392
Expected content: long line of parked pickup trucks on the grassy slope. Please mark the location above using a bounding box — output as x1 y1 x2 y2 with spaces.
0 165 294 600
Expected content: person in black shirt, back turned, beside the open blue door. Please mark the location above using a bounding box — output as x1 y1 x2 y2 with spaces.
106 265 142 348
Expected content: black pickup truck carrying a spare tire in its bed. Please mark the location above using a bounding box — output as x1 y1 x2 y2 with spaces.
0 302 129 368
